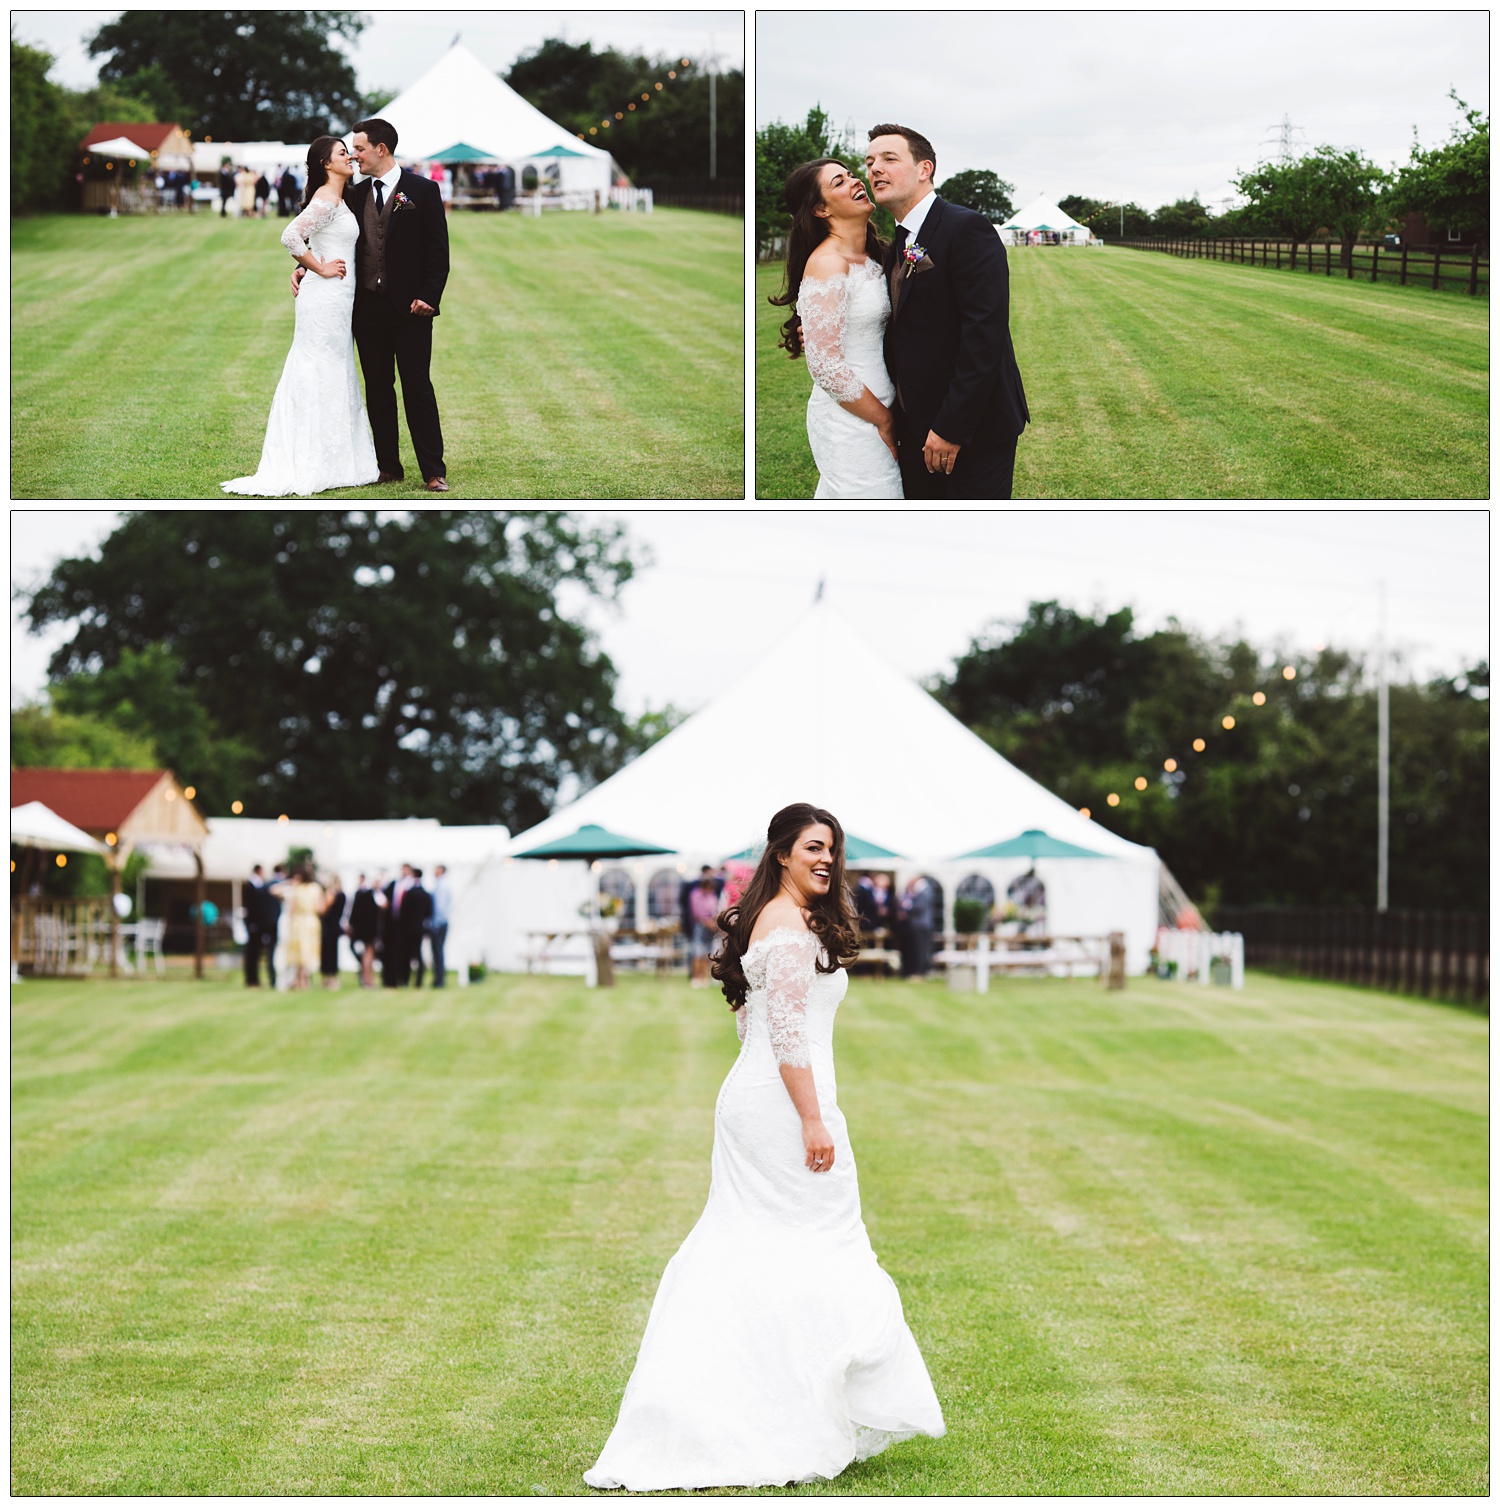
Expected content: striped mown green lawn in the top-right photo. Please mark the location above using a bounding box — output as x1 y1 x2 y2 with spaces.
755 247 1489 499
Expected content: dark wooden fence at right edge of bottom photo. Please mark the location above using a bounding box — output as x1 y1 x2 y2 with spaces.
1215 906 1489 1014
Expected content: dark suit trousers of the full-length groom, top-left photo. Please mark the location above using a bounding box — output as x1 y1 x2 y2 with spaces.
354 292 448 481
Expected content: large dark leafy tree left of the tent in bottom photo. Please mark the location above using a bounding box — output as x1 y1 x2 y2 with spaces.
27 509 635 830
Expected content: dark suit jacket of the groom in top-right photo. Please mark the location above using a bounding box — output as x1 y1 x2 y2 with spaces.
885 199 1031 451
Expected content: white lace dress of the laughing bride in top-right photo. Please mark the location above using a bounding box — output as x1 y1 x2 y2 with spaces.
797 256 905 502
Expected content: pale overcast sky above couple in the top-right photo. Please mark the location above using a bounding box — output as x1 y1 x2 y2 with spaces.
755 11 1489 209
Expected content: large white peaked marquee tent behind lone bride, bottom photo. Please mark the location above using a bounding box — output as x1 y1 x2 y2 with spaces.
473 603 1159 971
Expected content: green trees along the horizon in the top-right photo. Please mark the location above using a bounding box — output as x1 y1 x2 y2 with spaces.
755 92 1489 265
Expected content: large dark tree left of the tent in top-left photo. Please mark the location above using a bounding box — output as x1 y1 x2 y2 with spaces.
89 11 365 142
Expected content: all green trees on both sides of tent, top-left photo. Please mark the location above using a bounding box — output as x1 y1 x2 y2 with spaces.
11 11 745 214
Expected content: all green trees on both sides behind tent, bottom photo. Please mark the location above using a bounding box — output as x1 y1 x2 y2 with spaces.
11 509 1489 910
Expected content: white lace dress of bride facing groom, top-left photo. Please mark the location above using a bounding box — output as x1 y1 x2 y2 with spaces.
223 199 380 497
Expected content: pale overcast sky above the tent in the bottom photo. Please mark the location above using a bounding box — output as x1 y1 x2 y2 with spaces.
11 506 1489 714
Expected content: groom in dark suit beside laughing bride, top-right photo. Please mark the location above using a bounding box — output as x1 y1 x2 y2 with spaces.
865 125 1031 502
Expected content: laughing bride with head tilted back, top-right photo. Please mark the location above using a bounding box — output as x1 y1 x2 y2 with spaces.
770 157 903 500
